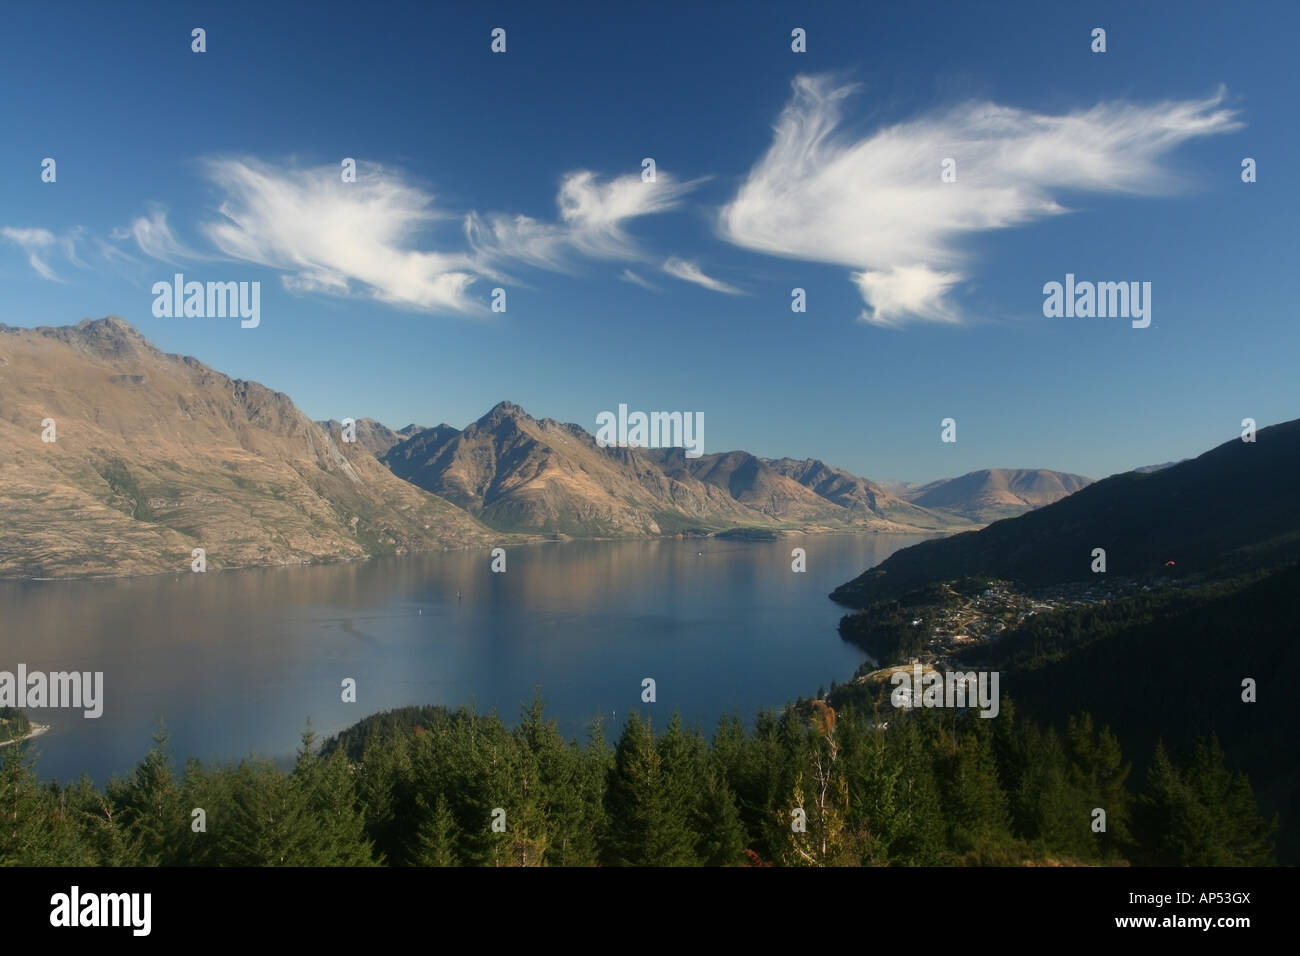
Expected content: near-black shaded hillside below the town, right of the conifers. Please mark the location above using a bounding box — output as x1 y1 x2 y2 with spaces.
963 566 1300 862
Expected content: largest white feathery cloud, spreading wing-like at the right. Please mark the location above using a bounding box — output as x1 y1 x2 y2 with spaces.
719 75 1240 325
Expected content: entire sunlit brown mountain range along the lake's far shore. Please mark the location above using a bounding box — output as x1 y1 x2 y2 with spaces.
0 317 1087 578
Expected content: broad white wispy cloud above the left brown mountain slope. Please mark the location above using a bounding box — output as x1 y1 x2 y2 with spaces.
203 159 484 312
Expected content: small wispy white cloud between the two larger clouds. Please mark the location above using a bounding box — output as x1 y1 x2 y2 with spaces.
465 170 698 273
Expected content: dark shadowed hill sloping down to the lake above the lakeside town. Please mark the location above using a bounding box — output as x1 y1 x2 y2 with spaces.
831 421 1300 607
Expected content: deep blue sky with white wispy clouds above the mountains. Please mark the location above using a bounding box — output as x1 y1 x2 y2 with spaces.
0 3 1300 480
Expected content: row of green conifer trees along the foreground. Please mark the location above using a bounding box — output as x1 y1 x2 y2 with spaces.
0 700 1275 866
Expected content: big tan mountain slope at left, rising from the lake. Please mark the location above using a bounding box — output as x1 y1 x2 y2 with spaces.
0 317 501 578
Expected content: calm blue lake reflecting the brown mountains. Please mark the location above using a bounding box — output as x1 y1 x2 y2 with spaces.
0 535 927 783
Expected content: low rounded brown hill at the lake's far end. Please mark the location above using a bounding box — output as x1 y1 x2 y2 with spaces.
902 468 1092 523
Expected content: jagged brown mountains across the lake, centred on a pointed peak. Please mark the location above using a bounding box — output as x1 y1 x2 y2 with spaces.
382 402 971 536
